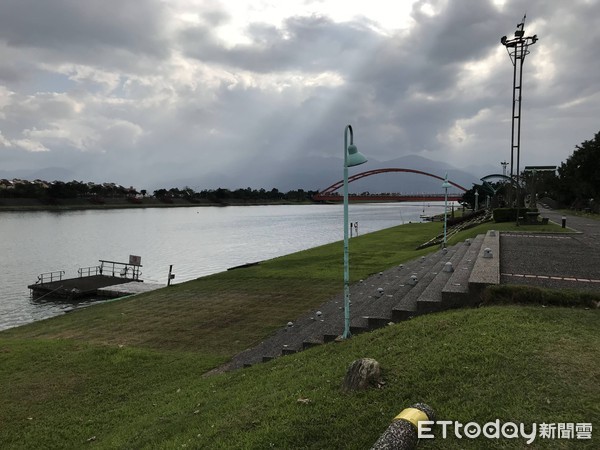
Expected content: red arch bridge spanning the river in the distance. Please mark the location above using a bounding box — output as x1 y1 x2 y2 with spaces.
313 168 467 202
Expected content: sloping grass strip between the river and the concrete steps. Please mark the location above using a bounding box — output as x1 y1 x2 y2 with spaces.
0 224 440 358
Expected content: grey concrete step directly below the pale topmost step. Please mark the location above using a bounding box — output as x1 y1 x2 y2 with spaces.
442 234 485 308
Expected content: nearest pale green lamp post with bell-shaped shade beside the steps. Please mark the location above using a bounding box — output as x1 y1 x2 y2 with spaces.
342 125 367 339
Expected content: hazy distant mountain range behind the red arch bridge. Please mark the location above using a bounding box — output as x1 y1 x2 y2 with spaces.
0 155 482 193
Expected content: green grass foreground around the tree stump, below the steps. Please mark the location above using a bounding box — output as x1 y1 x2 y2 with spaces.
0 306 600 449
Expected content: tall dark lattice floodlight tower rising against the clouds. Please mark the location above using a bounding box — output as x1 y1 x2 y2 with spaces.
500 15 538 204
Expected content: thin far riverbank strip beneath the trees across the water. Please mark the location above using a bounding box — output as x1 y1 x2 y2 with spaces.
0 197 314 212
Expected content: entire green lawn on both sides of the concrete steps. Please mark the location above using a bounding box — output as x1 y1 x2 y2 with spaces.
0 217 600 449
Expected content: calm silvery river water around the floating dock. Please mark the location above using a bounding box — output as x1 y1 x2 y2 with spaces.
0 203 450 330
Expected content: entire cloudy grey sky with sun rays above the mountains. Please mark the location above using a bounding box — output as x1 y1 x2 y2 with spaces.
0 0 600 188
